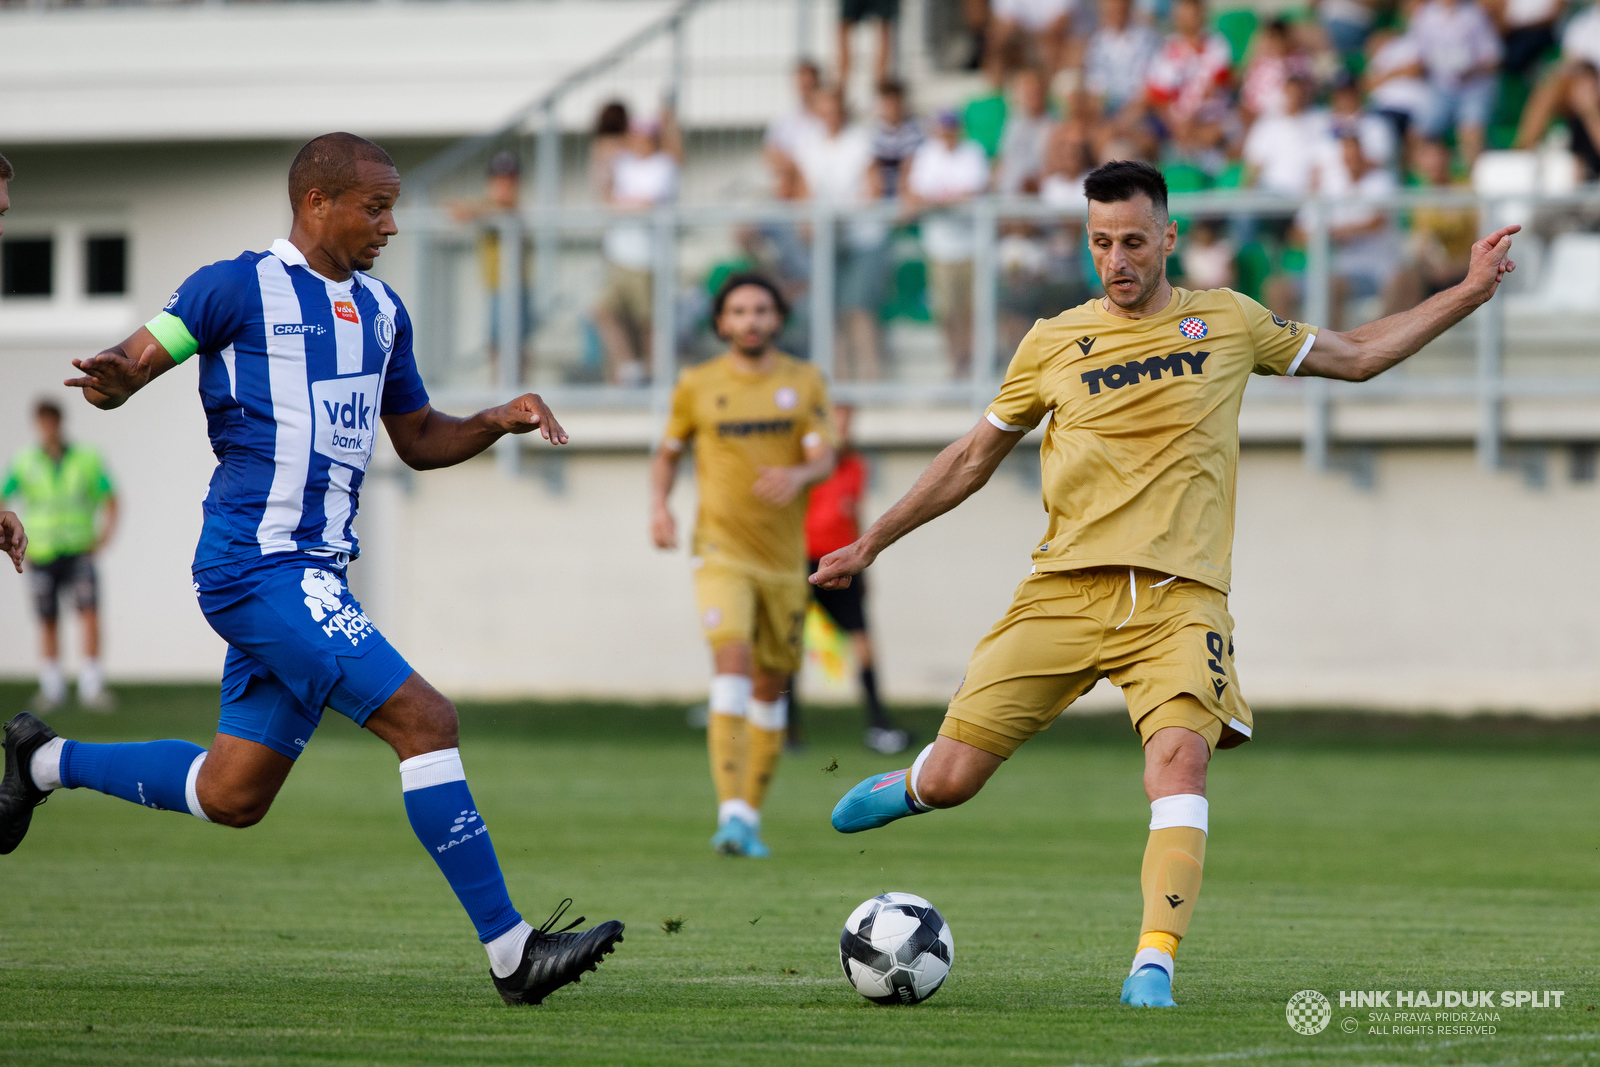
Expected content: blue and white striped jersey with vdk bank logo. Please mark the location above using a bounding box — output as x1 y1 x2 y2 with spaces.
149 240 427 569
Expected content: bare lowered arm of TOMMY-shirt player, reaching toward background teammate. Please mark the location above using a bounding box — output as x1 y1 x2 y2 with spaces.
811 419 1027 589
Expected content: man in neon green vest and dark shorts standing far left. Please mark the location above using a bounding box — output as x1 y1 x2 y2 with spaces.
0 400 117 710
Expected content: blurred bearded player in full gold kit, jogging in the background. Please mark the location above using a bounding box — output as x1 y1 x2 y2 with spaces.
650 274 835 857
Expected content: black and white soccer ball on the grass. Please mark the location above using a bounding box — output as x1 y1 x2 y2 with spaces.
838 893 955 1005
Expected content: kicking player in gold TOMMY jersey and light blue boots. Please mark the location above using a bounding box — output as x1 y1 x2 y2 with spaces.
811 162 1518 1008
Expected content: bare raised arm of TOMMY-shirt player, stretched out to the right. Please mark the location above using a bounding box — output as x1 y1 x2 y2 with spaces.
1298 226 1522 382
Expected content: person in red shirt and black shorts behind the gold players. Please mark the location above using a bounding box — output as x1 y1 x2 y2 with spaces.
789 403 910 755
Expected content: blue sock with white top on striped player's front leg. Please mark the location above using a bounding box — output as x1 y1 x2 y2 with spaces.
400 749 522 942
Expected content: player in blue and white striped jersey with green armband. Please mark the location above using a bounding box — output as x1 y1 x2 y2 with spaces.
0 133 622 1003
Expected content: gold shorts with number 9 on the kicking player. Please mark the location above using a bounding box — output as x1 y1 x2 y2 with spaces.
939 566 1251 758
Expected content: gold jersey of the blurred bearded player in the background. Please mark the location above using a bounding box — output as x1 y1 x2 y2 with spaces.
664 355 834 571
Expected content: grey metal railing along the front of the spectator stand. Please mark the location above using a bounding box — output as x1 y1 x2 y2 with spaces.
403 190 1600 469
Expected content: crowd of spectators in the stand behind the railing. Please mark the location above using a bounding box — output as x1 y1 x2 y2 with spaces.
579 0 1600 381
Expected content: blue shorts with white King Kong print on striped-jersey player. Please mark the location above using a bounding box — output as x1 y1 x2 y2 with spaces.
194 555 411 760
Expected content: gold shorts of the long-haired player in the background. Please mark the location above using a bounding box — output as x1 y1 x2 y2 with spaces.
694 557 811 673
